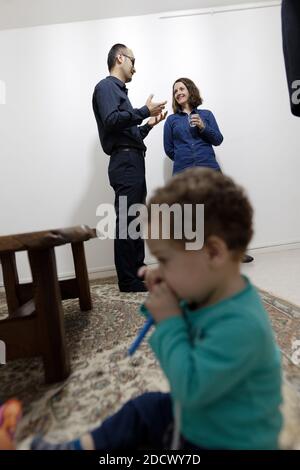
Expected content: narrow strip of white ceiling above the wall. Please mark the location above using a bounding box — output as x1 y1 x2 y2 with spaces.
0 0 272 30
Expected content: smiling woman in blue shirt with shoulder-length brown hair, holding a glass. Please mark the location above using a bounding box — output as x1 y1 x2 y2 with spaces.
164 78 223 173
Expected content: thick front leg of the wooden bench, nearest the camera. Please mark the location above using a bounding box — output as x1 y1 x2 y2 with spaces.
28 248 70 383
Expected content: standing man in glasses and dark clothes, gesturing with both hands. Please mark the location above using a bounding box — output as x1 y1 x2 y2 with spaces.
93 44 167 292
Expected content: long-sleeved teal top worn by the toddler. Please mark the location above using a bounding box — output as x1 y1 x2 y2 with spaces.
149 277 282 449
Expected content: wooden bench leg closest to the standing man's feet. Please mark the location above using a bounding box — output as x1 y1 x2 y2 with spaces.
72 242 92 311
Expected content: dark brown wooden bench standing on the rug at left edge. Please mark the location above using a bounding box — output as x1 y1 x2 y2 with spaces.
0 225 96 383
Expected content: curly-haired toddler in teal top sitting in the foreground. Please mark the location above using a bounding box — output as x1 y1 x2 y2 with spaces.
32 168 282 452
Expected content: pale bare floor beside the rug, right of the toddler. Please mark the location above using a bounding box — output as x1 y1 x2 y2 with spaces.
243 248 300 306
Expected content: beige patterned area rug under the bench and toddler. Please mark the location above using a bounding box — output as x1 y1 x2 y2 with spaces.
0 278 300 449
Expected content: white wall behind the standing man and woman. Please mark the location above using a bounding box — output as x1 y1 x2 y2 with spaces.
0 2 300 278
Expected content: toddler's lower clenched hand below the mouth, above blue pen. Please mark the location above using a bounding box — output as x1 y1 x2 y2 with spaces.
145 281 181 323
